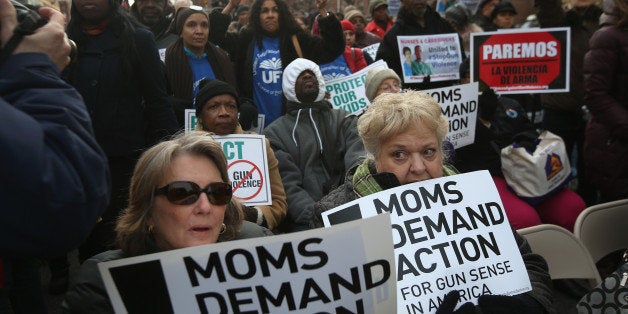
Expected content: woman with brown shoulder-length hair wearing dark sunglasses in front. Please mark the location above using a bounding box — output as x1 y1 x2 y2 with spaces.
63 132 269 313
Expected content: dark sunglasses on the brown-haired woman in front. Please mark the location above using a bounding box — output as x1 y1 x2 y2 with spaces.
155 181 232 205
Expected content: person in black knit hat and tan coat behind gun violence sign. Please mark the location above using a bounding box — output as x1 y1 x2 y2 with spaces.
195 79 288 230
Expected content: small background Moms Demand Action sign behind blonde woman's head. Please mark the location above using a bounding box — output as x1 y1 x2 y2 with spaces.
424 82 478 148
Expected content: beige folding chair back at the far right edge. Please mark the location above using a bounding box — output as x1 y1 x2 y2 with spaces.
574 199 628 262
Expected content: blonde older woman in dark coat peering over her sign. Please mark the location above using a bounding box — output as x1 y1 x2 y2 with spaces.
311 90 552 314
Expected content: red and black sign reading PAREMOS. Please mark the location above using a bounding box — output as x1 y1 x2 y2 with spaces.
471 27 571 94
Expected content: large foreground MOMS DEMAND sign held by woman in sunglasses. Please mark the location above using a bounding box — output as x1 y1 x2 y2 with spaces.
98 215 397 314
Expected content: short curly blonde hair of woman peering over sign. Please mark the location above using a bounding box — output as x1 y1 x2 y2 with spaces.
358 90 449 157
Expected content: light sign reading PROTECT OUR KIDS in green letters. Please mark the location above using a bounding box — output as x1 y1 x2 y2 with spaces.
325 60 388 114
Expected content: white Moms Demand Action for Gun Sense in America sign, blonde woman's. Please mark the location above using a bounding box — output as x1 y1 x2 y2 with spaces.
323 170 531 313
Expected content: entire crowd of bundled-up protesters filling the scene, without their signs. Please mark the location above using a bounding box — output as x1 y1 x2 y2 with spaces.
0 0 628 313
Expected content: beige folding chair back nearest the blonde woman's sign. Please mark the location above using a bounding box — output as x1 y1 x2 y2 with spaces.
517 224 602 287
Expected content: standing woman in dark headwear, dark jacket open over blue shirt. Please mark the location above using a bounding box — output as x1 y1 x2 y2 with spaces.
166 6 236 126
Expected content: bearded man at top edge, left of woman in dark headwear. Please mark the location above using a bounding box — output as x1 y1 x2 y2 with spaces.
131 0 177 52
